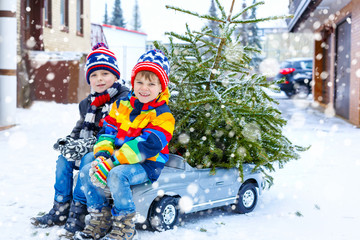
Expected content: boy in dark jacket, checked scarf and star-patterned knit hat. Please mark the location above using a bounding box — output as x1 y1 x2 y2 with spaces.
32 43 129 236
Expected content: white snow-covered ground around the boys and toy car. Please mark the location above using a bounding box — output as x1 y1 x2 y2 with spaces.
0 91 360 240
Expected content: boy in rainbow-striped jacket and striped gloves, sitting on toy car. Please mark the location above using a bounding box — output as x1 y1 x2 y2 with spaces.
74 50 175 240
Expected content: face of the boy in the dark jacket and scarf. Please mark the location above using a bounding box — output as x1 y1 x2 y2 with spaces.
89 69 117 93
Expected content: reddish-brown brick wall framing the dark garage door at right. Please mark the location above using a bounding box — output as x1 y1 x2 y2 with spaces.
313 0 360 127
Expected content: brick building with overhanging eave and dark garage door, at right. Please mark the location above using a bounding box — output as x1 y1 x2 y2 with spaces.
288 0 360 127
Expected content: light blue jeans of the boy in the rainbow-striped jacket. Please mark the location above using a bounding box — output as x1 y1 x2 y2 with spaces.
80 160 149 216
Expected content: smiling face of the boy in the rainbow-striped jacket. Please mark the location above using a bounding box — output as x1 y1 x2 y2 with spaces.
134 74 161 103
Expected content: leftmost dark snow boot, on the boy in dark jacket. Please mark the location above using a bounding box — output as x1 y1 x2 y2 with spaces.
31 201 70 228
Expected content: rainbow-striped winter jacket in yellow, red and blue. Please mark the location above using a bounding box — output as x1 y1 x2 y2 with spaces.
94 88 175 181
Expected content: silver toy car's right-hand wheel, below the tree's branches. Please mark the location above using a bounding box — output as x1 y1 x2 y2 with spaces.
235 183 258 213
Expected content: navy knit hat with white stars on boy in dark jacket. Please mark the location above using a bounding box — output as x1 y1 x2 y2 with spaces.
85 43 120 84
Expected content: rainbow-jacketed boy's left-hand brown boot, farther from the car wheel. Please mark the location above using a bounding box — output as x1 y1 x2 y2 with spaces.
73 207 112 240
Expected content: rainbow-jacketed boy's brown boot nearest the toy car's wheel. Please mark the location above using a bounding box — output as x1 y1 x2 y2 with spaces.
101 213 136 240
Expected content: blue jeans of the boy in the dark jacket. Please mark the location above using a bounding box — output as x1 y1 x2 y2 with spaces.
54 152 94 204
